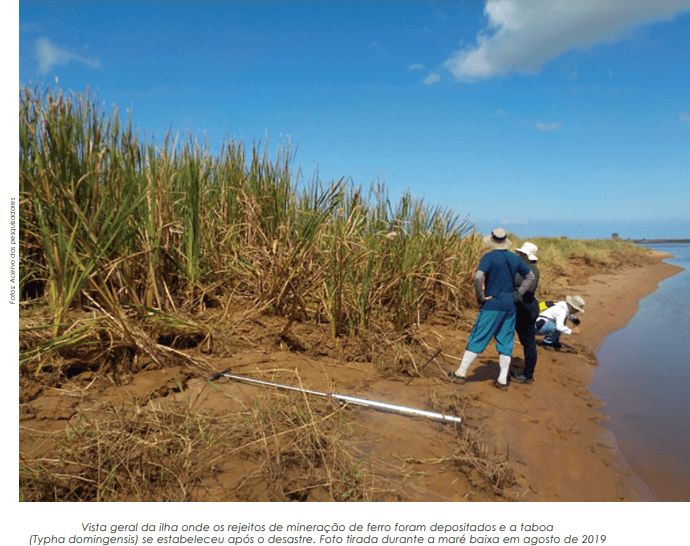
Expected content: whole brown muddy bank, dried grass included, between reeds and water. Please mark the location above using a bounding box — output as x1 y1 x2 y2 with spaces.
19 249 678 501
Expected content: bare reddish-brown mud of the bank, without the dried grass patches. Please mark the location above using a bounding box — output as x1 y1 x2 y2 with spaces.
19 251 680 501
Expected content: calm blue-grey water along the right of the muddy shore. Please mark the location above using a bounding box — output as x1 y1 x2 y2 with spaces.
590 244 690 501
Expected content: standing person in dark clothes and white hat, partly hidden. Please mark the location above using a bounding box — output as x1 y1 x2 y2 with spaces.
510 242 539 384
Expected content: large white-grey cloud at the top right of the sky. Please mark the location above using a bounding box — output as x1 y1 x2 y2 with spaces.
443 0 690 82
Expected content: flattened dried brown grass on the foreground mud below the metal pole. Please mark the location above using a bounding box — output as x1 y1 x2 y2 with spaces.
19 368 512 502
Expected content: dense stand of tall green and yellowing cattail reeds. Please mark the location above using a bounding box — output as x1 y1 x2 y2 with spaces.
19 88 481 366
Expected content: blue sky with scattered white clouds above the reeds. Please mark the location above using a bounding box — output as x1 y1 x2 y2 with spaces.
18 0 690 238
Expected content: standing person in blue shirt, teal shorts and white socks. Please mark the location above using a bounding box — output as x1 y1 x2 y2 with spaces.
448 228 535 389
